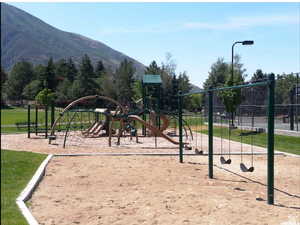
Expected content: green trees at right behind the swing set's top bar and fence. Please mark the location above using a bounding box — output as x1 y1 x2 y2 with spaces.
203 55 300 107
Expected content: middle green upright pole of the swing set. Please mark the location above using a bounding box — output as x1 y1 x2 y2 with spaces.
208 88 213 179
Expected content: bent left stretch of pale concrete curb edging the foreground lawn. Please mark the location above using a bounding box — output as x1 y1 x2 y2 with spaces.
16 155 53 225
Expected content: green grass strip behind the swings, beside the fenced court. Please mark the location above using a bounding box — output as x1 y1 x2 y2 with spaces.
202 126 300 155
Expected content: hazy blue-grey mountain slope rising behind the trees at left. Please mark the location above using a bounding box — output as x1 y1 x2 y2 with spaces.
1 3 145 74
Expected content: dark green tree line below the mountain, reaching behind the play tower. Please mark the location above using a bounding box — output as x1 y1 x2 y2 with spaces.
1 55 195 109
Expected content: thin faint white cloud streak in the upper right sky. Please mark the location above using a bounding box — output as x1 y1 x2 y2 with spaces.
183 15 300 30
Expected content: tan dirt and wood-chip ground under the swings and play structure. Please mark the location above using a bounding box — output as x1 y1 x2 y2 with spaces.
1 135 300 225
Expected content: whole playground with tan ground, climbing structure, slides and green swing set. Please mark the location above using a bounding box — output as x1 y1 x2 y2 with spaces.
1 75 300 225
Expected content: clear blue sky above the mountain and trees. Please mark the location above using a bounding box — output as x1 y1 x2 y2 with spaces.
9 2 300 86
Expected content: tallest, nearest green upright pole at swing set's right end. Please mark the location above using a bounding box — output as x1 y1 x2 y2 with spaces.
268 74 275 205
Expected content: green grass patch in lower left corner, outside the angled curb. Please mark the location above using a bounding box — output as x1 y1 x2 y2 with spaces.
1 150 46 225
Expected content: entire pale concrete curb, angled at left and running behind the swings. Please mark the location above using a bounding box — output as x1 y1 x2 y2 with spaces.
16 151 300 225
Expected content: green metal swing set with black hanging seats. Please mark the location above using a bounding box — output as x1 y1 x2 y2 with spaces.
178 74 275 205
